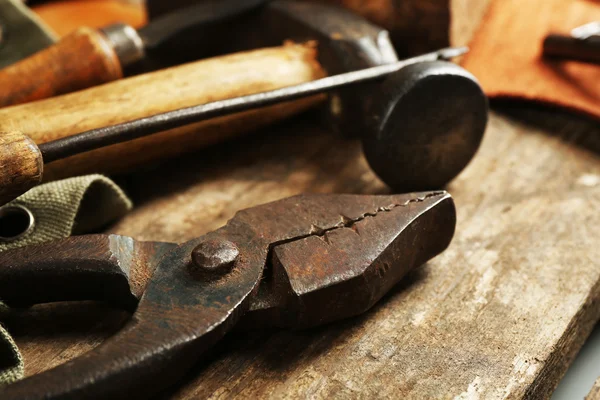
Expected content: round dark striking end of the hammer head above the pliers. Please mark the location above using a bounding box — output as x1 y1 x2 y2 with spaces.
363 61 488 191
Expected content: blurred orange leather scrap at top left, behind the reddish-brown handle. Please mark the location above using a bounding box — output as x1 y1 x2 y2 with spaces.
33 0 146 36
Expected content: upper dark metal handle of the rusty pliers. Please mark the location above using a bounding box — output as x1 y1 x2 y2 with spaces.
0 235 176 310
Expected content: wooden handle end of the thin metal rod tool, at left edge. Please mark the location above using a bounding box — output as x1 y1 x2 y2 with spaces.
0 131 44 206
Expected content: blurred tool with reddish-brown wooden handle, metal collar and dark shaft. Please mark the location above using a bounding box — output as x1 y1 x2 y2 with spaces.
0 0 266 107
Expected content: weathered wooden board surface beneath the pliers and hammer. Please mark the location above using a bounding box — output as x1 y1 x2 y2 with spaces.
6 4 600 399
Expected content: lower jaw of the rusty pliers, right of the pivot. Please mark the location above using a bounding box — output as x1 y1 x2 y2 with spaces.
242 192 456 329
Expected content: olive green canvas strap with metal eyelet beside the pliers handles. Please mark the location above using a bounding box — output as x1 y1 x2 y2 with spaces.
0 175 132 385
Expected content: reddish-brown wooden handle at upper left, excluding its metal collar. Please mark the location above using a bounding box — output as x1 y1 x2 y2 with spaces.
0 28 123 107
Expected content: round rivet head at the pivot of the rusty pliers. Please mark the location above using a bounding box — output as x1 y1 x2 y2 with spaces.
188 240 240 278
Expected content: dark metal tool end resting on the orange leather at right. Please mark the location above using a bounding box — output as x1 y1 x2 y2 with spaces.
544 22 600 64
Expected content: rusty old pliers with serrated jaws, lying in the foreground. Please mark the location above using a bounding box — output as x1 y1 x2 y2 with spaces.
0 192 456 400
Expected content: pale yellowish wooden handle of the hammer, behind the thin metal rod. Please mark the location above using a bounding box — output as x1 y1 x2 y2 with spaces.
0 44 324 179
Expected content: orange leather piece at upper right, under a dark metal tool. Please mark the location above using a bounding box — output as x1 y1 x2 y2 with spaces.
462 0 600 119
